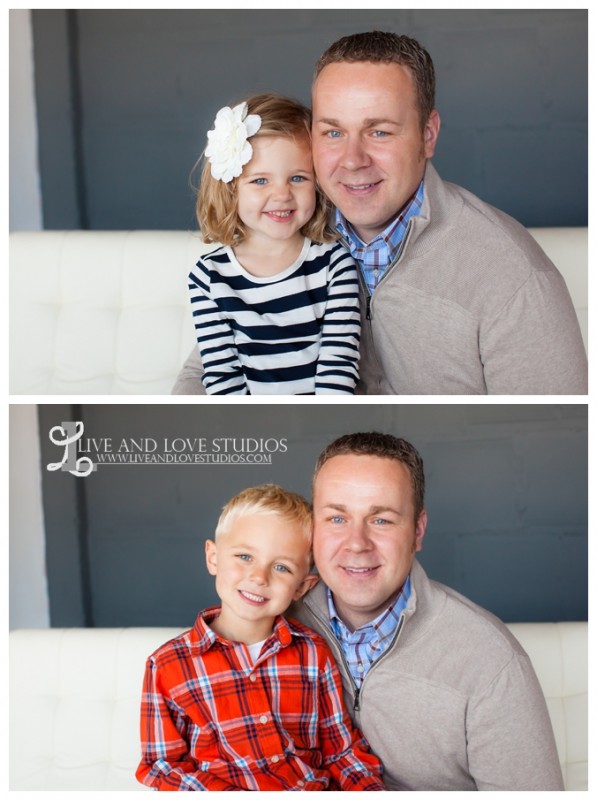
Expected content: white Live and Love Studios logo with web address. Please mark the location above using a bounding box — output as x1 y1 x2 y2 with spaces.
47 422 288 478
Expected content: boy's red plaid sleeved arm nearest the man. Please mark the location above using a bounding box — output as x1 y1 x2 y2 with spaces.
319 653 385 791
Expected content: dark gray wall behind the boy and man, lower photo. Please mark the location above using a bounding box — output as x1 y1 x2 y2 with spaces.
40 403 587 626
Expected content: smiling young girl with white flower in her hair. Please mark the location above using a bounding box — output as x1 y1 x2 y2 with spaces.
189 94 360 394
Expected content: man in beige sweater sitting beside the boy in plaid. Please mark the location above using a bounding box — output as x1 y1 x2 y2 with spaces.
288 433 563 791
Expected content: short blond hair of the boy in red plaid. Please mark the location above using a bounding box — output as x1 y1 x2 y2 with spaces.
215 483 313 548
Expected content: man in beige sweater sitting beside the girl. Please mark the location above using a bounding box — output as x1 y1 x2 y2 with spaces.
173 31 588 394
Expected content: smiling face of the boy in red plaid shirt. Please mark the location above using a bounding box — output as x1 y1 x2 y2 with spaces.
205 513 317 644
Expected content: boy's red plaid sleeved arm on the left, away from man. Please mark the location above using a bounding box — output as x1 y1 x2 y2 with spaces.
136 657 241 792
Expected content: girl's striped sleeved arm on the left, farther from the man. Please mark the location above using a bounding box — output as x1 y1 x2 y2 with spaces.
189 260 249 394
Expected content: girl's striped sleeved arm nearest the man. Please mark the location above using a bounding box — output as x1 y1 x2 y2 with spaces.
315 247 361 394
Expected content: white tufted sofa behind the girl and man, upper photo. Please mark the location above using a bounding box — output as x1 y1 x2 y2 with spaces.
9 228 588 395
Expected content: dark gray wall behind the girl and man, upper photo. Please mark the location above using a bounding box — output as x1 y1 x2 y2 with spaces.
33 10 588 229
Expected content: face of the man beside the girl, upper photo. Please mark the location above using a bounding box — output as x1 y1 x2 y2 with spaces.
313 62 439 242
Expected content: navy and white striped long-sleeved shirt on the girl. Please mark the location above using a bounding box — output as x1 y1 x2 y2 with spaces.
189 239 360 394
